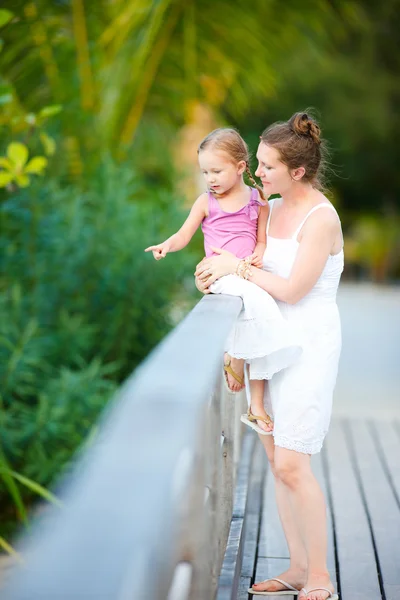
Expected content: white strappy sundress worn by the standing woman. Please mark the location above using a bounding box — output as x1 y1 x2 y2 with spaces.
246 200 344 454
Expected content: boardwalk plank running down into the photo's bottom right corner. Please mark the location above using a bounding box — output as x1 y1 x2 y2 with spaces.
347 422 400 600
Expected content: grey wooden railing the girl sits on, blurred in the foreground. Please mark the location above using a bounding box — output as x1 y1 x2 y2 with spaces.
1 296 250 600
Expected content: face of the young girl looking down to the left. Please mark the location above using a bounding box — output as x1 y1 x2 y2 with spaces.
199 149 246 194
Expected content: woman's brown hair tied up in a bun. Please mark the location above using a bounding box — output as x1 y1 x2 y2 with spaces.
260 110 327 189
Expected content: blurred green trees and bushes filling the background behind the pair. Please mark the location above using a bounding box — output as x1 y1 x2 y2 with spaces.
0 0 400 541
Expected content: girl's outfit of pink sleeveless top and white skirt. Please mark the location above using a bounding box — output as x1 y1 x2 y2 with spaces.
202 188 302 379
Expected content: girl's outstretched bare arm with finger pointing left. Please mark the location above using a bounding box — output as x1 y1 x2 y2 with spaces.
145 194 208 260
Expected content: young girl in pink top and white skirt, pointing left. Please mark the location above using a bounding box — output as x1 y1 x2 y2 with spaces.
145 128 302 435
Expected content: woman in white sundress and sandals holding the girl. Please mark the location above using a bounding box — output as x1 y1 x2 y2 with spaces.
196 113 343 600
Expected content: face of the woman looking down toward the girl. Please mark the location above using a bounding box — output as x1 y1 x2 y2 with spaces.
256 142 293 196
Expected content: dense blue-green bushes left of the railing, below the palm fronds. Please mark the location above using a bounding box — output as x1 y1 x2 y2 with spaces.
0 160 195 536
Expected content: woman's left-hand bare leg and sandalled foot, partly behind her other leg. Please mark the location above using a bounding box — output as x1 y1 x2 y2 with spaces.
253 435 307 592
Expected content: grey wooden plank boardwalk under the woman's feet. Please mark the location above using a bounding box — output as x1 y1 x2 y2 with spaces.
218 418 400 600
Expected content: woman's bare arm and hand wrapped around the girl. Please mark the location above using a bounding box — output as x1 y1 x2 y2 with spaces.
196 211 338 304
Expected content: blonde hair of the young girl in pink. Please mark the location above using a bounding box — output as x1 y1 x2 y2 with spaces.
197 127 265 201
